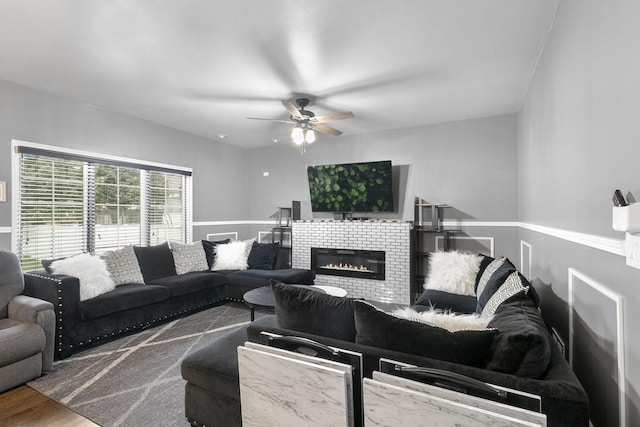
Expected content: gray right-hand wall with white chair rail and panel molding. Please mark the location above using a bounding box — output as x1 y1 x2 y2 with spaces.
518 0 640 427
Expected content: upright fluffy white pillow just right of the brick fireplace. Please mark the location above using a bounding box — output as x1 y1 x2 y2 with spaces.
424 251 482 296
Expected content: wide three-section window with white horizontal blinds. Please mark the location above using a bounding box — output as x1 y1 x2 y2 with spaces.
15 143 191 270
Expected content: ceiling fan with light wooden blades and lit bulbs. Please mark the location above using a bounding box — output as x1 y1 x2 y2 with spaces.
247 98 354 144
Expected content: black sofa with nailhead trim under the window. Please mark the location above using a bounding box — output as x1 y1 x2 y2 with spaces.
23 243 315 359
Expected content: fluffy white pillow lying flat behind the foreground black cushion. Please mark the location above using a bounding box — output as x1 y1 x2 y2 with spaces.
392 307 493 332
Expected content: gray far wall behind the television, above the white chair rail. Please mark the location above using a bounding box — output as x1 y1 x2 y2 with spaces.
249 115 517 221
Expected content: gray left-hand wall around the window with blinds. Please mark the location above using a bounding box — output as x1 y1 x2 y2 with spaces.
0 80 249 249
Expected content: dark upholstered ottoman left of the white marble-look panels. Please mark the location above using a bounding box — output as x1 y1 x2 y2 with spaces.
181 325 247 427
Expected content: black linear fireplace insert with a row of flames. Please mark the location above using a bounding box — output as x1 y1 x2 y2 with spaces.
311 248 385 280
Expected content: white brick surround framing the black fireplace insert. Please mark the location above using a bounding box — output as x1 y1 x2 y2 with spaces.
291 220 412 304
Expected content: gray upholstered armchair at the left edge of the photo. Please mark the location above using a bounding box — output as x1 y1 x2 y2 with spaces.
0 251 55 392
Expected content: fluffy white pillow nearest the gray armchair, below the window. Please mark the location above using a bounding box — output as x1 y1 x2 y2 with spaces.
51 254 116 301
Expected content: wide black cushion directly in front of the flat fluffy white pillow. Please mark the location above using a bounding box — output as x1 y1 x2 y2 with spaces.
354 301 498 366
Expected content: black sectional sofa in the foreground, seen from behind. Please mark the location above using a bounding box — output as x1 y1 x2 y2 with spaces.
182 261 589 427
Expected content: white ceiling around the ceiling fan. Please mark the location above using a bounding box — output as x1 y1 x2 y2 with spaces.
0 0 560 147
